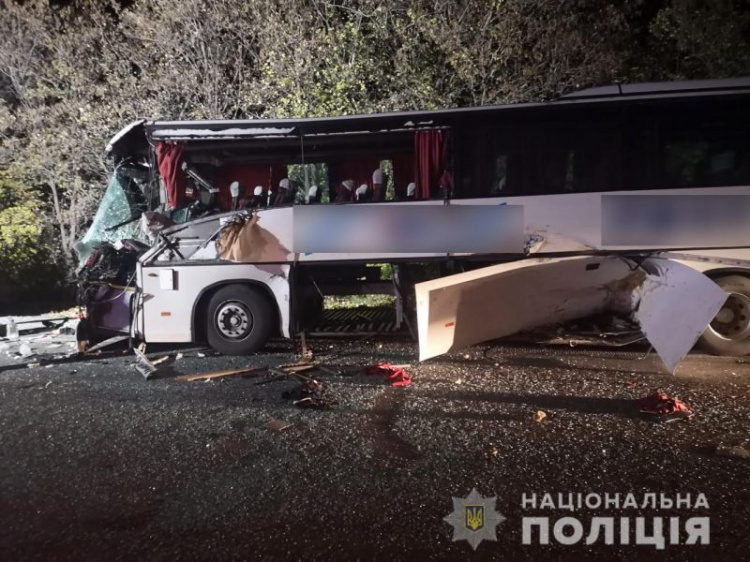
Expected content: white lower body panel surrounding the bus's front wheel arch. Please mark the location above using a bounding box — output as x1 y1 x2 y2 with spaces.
139 264 290 342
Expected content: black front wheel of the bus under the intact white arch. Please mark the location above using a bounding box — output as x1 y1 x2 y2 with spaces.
206 285 277 355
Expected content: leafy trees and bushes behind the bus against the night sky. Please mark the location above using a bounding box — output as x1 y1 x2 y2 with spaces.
0 0 750 315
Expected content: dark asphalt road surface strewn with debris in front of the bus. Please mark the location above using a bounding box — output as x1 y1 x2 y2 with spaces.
0 330 750 561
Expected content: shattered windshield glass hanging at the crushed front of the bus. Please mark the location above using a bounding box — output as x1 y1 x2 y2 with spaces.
74 165 146 268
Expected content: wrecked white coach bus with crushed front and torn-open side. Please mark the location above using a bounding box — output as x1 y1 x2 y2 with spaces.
76 79 750 368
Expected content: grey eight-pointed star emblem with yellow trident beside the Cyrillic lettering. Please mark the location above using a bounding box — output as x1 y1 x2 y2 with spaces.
443 489 505 550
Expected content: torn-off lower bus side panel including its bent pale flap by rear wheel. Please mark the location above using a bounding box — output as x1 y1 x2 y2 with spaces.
416 252 727 372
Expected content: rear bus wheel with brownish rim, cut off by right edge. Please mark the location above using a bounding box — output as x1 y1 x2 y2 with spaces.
700 275 750 356
